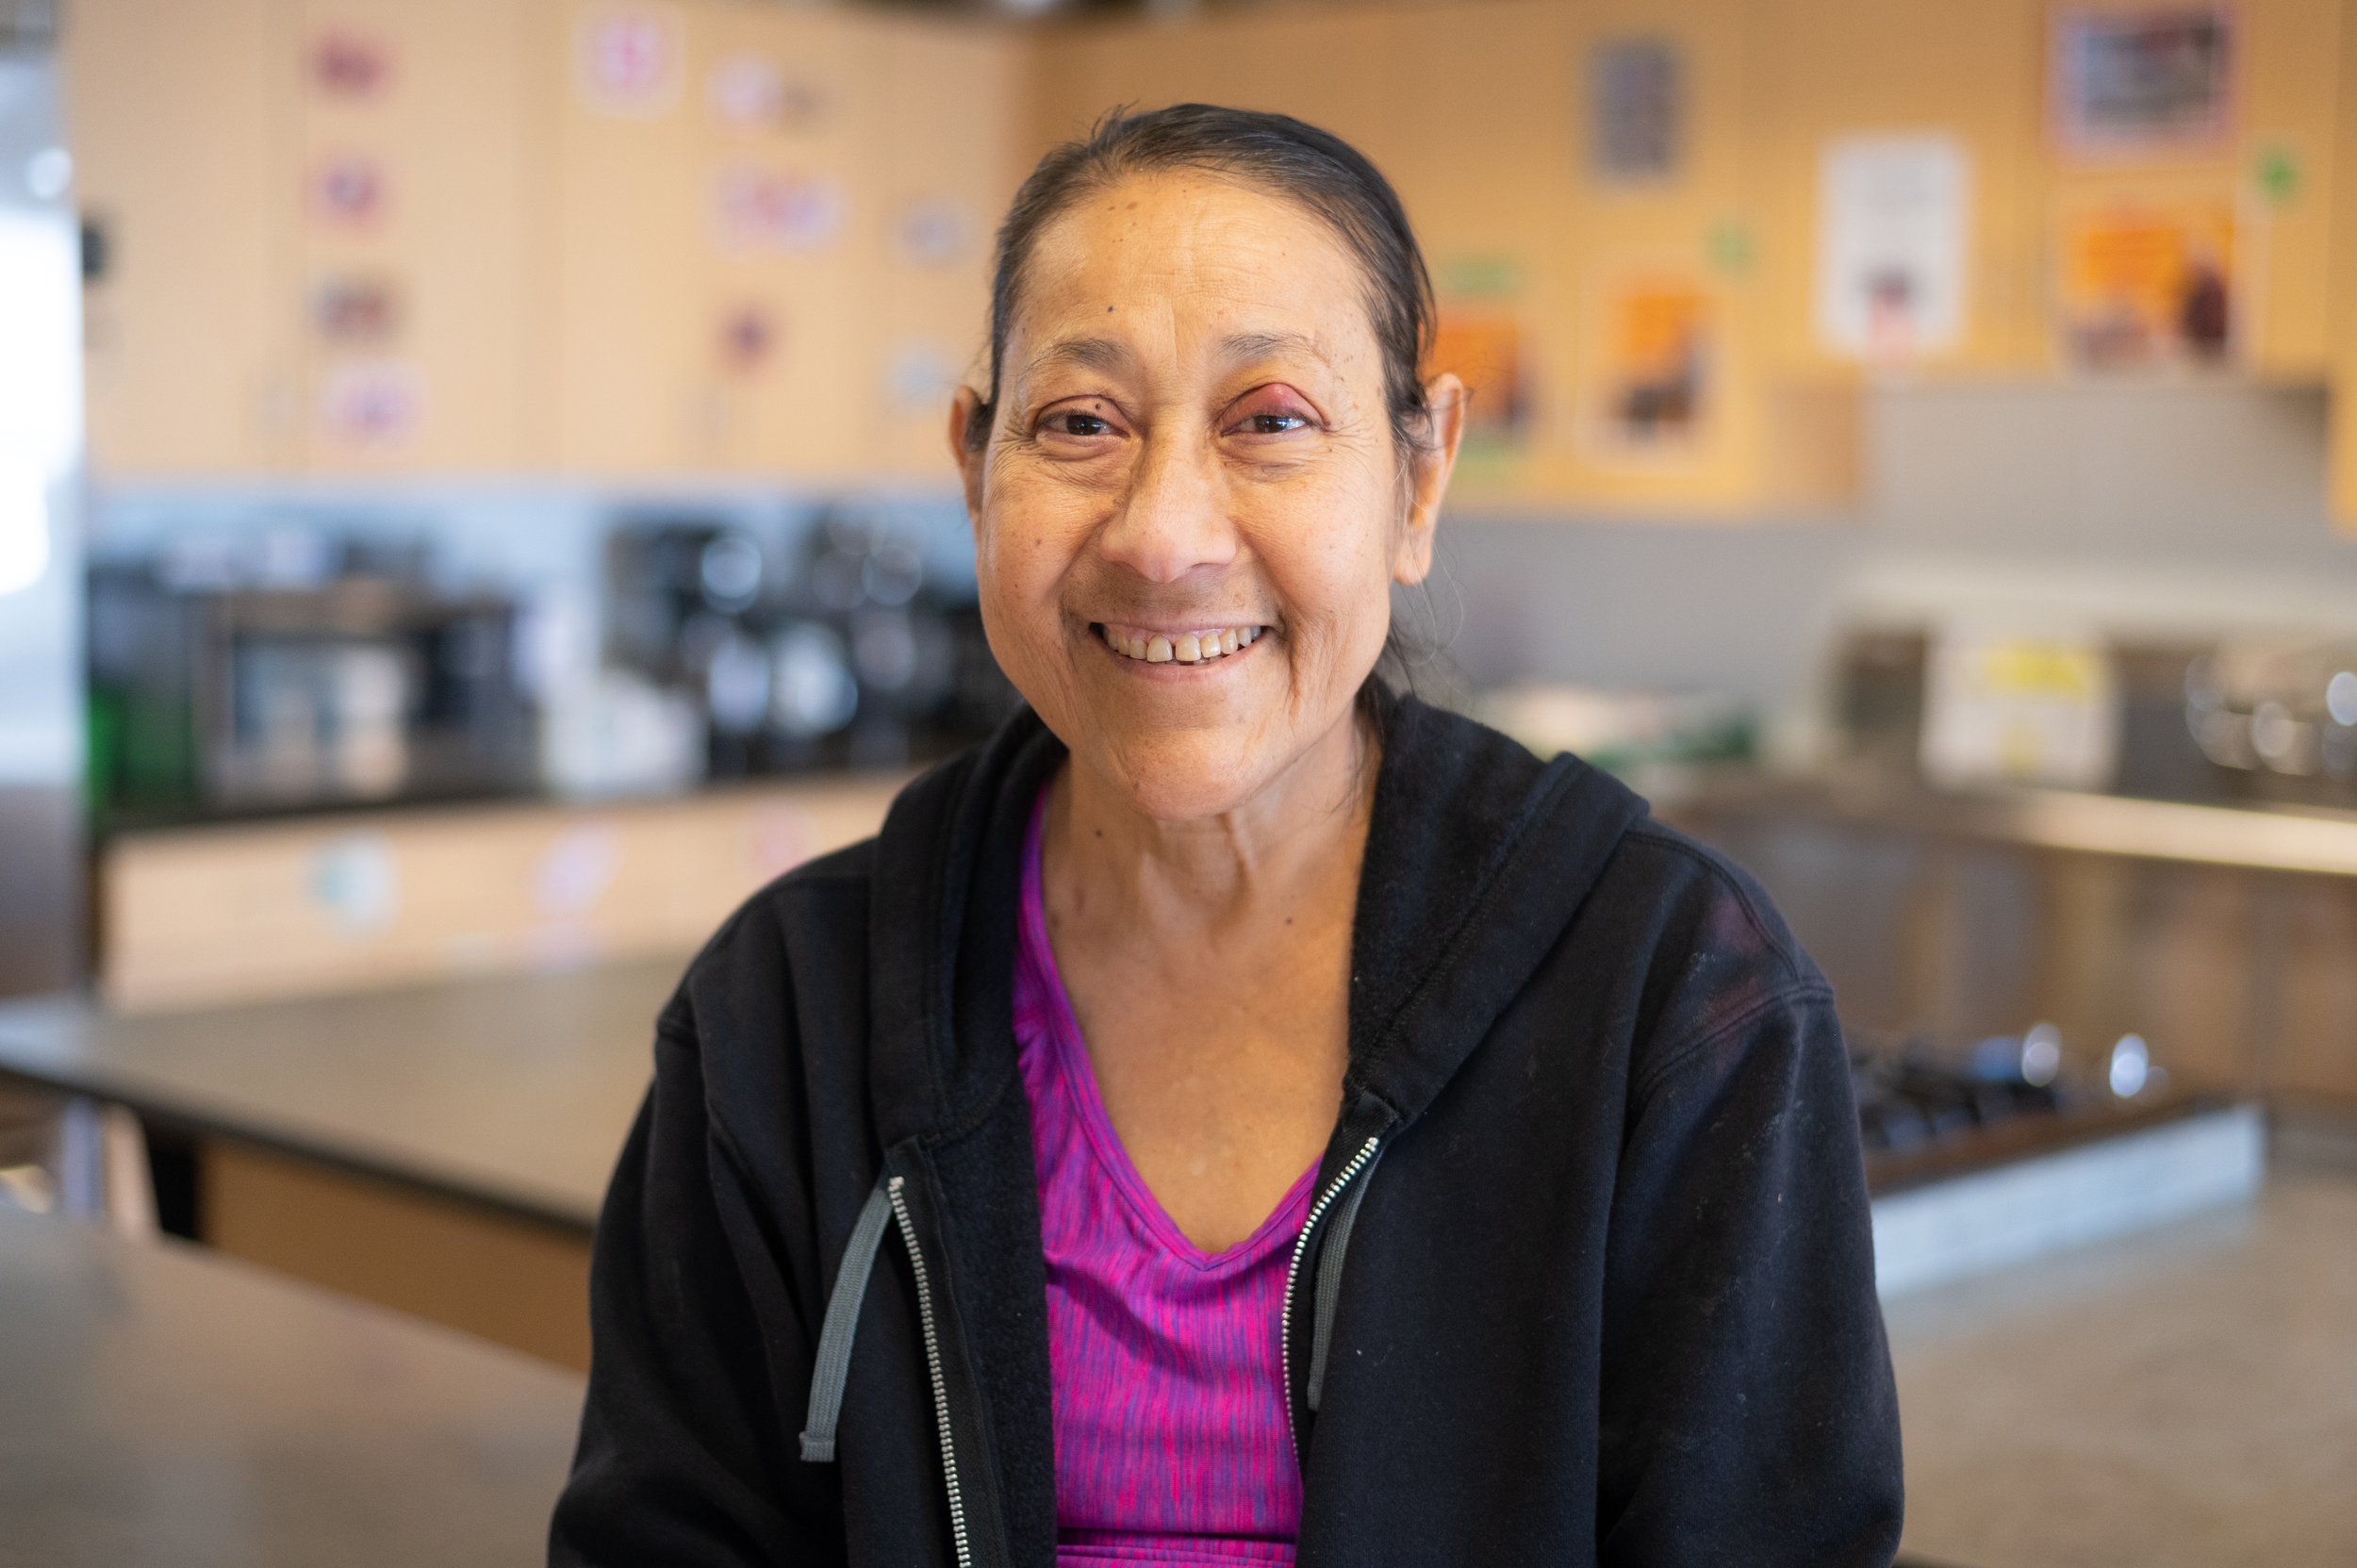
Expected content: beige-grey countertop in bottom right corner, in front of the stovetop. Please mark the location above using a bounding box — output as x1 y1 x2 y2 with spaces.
1888 1169 2357 1568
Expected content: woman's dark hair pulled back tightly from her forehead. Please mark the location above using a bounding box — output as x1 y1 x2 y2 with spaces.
966 104 1433 457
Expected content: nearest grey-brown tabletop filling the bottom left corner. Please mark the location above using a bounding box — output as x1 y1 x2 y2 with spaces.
0 1210 583 1568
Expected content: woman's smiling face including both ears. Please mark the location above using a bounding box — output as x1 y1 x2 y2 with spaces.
950 173 1457 820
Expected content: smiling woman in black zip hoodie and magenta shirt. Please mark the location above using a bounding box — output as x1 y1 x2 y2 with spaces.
552 104 1900 1568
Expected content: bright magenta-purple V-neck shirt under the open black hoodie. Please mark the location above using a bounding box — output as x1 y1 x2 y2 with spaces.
1014 792 1318 1568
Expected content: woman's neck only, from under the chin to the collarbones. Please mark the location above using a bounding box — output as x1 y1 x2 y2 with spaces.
1042 712 1376 948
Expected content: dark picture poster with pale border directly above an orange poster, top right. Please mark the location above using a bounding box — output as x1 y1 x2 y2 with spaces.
2049 5 2234 160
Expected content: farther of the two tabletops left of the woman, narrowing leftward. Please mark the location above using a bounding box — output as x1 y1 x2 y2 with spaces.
0 955 686 1230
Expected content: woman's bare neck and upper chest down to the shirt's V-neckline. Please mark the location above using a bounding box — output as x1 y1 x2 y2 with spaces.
1042 715 1376 1252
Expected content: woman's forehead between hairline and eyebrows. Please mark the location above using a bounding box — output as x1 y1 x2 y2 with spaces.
1004 173 1381 385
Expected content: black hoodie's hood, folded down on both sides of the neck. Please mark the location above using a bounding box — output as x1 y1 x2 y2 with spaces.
870 688 1645 1148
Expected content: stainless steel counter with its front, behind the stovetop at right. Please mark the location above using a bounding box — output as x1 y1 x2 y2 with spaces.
1662 776 2357 1098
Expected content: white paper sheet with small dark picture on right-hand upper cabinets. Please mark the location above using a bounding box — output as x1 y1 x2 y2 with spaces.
1818 137 1970 366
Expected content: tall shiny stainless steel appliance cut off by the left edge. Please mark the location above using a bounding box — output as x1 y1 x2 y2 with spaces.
0 0 83 995
